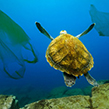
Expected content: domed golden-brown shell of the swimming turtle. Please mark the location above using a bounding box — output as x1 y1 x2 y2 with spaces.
46 34 94 77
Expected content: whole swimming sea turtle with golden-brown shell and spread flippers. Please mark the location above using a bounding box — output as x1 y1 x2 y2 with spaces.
36 22 98 87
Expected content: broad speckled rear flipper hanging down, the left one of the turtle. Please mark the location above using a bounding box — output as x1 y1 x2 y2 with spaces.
63 72 76 87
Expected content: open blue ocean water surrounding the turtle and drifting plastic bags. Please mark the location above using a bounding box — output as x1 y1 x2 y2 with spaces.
0 0 109 107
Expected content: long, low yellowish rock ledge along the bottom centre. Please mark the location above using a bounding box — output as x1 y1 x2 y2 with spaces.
22 95 90 109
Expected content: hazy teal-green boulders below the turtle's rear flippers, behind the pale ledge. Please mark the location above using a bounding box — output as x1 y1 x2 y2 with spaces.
45 80 109 99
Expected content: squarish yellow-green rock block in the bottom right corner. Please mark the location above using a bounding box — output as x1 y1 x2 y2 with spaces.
91 83 109 109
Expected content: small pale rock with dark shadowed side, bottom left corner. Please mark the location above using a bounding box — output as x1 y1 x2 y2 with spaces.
0 95 19 109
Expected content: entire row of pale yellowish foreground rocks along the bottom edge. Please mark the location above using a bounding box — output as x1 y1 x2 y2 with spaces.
0 83 109 109
